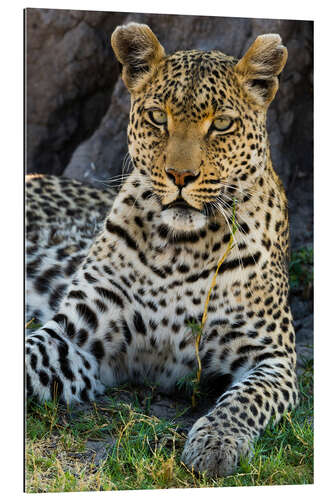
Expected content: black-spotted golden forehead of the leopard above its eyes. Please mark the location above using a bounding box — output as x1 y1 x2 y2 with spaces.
138 50 244 121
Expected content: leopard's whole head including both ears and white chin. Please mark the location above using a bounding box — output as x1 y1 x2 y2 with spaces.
111 23 287 232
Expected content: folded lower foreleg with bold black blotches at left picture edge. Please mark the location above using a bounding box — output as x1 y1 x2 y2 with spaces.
26 321 104 403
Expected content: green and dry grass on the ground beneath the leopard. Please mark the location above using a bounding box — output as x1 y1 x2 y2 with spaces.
26 362 313 493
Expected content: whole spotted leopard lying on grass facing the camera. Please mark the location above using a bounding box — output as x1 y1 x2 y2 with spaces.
26 23 299 477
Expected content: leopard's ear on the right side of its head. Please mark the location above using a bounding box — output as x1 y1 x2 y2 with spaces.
234 34 288 107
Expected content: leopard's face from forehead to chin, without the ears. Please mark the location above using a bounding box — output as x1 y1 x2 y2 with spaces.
128 51 266 232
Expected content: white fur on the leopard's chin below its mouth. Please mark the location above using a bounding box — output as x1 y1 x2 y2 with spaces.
161 208 207 232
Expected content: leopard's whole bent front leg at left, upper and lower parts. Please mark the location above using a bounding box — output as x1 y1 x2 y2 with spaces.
26 244 132 403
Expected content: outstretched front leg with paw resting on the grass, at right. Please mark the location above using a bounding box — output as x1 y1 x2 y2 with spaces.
182 358 298 476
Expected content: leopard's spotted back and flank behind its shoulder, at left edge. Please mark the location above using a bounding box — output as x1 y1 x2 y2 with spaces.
25 174 116 323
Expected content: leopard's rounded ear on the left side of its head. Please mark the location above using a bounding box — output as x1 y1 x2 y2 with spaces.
111 23 165 92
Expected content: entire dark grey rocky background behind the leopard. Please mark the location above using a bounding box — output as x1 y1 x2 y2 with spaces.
26 9 313 364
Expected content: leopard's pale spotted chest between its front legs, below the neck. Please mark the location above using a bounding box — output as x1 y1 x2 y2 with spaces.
83 222 270 389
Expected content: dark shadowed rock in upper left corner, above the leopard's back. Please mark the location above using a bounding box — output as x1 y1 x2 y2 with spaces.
26 9 124 175
